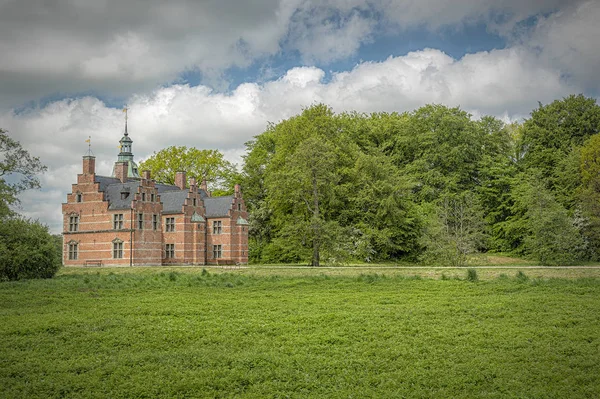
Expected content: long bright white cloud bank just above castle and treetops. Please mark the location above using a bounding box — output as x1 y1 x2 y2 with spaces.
0 47 579 231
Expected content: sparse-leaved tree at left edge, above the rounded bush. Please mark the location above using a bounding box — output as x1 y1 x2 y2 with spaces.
0 129 46 217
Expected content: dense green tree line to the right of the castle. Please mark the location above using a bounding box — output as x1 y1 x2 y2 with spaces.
240 95 600 265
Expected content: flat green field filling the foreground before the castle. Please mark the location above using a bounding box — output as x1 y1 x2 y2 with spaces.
0 268 600 398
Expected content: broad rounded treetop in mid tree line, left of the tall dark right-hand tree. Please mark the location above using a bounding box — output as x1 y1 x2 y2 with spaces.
390 105 494 202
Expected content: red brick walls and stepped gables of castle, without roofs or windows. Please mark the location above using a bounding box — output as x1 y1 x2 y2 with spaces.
62 157 248 266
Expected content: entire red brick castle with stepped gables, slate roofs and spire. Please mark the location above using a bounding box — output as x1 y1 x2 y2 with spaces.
62 128 248 266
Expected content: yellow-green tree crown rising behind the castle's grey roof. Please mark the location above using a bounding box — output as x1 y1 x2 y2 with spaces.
139 146 239 195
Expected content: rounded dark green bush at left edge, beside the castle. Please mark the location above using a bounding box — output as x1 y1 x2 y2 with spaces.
0 218 62 281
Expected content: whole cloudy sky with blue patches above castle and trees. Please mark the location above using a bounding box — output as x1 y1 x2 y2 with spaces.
0 0 600 233
